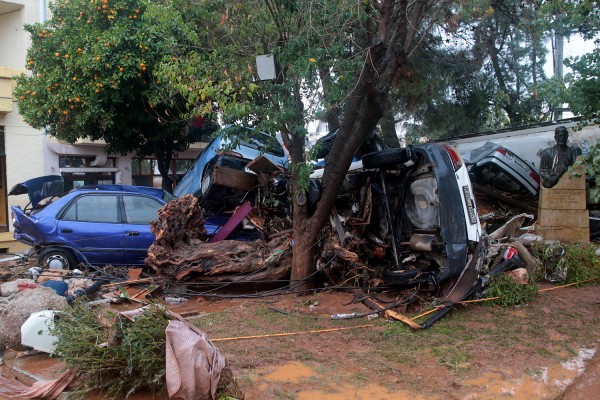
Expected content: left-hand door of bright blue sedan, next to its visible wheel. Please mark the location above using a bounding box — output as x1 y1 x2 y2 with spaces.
57 193 123 265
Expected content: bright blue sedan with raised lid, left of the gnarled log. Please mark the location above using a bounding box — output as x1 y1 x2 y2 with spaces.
10 176 225 269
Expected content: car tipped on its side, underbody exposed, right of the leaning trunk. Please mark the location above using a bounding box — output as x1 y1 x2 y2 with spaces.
314 143 482 287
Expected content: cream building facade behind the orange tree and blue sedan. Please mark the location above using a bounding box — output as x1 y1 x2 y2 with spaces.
0 0 205 238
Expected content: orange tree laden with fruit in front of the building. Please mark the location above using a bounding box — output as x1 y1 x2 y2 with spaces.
15 0 215 191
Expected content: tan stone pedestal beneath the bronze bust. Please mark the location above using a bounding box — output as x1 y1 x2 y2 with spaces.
536 162 590 242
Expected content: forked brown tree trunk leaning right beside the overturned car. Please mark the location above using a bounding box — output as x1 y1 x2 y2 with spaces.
282 0 439 290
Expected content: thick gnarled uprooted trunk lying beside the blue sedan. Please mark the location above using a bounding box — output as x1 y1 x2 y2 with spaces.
145 195 291 282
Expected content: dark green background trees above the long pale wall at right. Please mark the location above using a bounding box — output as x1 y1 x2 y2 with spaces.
404 0 551 138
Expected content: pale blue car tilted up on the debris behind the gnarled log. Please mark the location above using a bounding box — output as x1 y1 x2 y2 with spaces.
173 125 288 212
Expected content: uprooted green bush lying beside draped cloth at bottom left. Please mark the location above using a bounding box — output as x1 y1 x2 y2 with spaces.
53 302 168 398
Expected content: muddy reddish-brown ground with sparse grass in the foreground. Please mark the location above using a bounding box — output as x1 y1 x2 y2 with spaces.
185 286 600 400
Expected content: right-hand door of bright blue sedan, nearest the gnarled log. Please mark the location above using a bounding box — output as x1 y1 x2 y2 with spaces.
122 194 163 265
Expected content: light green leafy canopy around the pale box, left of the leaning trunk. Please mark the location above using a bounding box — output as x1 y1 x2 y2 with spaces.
148 0 366 153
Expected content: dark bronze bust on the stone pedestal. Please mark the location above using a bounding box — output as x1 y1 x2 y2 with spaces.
540 125 581 188
